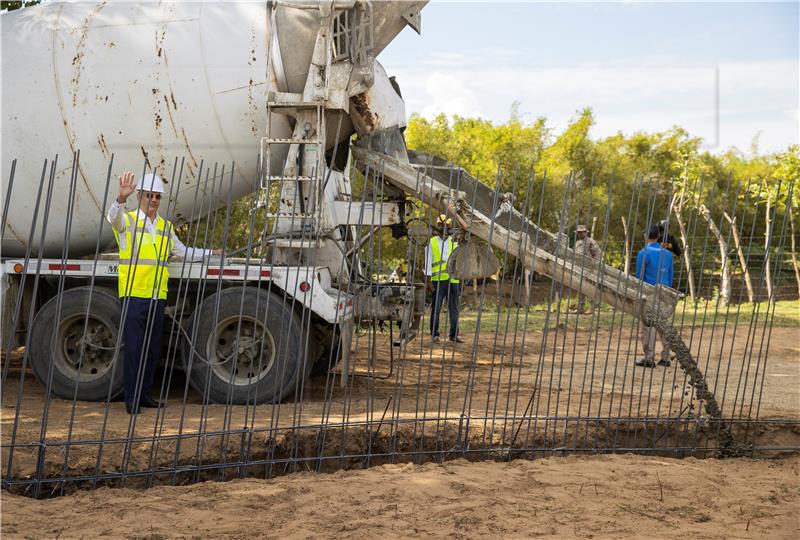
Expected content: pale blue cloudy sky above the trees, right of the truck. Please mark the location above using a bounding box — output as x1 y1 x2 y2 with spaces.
379 0 800 156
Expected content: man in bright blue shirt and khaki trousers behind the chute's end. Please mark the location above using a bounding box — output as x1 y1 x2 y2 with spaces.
636 225 673 367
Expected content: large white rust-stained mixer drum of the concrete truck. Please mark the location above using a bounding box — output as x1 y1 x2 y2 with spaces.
0 2 310 257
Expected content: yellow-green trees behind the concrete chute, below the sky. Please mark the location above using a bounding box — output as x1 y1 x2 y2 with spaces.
406 108 800 304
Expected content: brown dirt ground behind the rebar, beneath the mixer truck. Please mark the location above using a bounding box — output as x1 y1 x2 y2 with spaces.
0 327 800 484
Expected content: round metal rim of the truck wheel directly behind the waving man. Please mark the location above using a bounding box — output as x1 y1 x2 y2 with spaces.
53 313 117 383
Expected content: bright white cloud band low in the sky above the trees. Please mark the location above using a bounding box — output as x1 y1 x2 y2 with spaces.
395 58 800 152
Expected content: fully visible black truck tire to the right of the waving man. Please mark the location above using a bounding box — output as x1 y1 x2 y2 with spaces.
183 287 307 405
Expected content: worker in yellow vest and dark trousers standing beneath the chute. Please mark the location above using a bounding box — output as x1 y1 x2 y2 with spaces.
425 215 464 343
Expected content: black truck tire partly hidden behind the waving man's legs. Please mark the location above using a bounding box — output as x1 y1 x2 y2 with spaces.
30 287 123 401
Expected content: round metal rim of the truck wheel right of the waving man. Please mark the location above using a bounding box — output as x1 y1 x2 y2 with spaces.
206 315 275 386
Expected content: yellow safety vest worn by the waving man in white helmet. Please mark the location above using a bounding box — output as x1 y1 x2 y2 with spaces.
113 210 173 300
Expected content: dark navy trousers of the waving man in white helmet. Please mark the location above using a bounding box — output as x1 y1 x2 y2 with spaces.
122 297 167 403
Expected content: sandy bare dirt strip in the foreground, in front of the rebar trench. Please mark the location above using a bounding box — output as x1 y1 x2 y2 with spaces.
2 455 800 539
